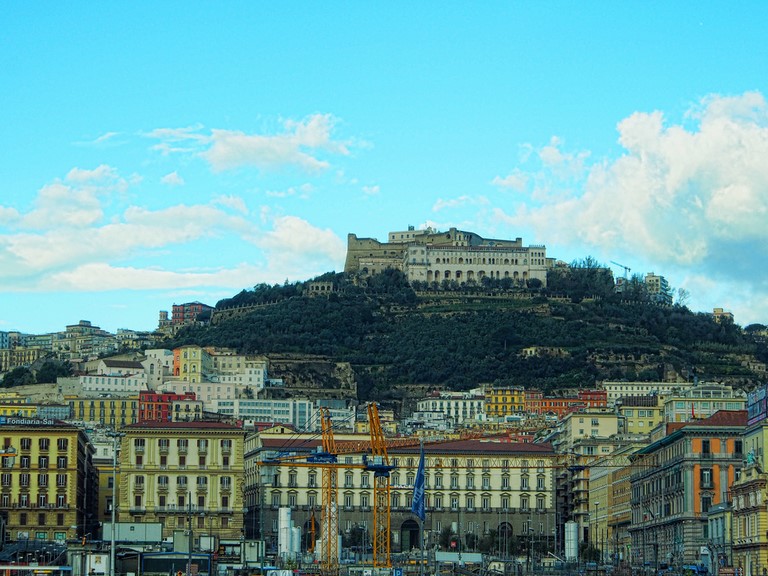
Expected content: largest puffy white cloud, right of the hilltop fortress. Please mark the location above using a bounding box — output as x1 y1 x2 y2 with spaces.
496 93 768 322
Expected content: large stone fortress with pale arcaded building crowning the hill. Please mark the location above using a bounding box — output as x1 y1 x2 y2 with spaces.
344 226 555 286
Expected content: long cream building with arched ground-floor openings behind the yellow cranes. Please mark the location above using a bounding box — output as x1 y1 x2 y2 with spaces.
252 432 557 552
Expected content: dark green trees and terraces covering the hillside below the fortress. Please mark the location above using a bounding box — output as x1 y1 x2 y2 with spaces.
167 262 768 400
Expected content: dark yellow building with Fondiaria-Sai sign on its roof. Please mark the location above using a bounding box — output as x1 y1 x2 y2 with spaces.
0 417 97 543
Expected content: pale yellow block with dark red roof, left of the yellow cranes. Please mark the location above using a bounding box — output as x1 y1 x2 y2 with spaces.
118 422 245 548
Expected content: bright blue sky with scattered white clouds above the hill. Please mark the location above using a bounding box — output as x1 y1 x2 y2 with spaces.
0 1 768 333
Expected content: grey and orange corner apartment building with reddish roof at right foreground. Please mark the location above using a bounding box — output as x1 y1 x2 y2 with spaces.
629 410 747 567
